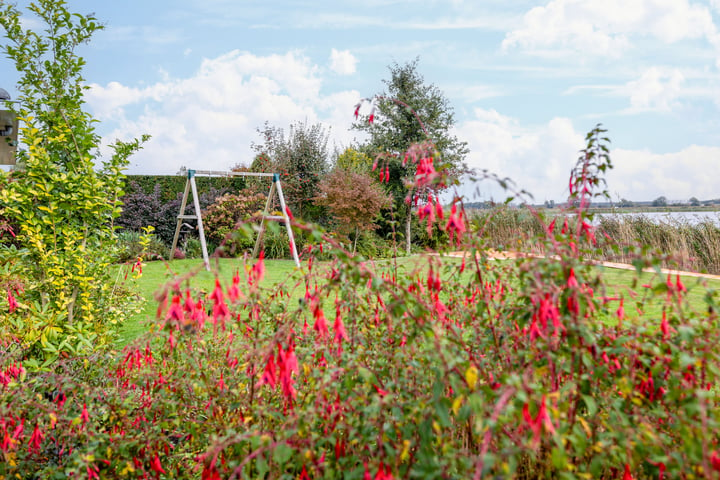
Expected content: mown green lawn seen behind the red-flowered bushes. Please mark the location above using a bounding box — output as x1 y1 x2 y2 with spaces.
120 256 720 345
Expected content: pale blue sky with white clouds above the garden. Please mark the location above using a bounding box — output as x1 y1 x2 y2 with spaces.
0 0 720 203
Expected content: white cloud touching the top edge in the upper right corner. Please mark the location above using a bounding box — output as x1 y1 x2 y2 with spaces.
502 0 720 57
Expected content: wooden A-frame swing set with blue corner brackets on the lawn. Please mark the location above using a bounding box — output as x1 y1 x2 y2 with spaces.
170 170 300 270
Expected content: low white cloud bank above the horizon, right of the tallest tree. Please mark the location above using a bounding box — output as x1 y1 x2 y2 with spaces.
457 109 720 203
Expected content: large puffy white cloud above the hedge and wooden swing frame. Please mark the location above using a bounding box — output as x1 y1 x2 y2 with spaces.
87 51 360 174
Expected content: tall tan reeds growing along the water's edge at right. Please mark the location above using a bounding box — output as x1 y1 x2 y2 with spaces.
472 207 720 274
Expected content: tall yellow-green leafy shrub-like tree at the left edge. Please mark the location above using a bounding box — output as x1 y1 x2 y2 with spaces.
0 0 147 358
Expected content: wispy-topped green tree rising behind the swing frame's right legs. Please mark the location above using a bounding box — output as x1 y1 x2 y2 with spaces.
251 122 329 221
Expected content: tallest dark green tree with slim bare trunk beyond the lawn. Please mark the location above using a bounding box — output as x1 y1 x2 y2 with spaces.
353 58 468 253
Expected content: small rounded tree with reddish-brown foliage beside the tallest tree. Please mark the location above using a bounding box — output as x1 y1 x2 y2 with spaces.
315 168 392 253
